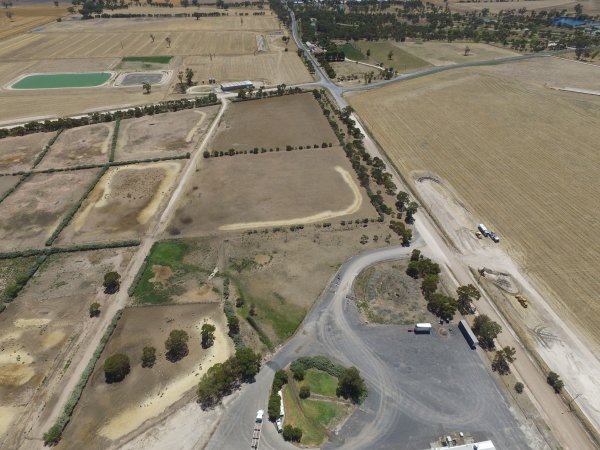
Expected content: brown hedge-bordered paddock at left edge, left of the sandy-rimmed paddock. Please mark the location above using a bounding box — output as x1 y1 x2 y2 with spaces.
0 169 98 251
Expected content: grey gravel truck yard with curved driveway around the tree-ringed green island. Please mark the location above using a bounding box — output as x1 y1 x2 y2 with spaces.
207 243 544 449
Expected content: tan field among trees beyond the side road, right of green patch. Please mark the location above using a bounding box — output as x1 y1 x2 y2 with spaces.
392 41 519 67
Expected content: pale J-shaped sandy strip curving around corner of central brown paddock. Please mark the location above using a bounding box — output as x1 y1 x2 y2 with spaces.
219 166 363 231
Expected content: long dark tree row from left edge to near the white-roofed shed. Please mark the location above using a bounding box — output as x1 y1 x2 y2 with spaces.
0 93 219 139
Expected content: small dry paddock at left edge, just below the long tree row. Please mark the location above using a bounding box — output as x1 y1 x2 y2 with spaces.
0 133 54 173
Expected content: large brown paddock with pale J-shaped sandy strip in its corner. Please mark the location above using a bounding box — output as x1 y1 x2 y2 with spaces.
169 147 375 236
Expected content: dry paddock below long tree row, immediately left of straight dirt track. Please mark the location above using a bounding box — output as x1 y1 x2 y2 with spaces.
115 106 219 161
